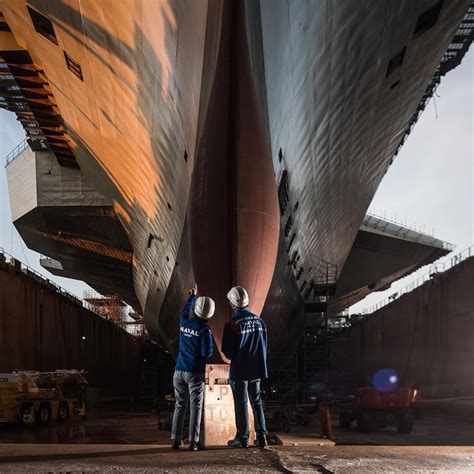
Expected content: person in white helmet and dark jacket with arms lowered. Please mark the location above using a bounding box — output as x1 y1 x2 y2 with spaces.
222 286 268 448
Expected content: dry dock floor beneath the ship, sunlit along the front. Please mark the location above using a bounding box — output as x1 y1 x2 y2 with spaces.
0 410 474 473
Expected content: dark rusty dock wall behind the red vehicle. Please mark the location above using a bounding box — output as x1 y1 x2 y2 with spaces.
344 257 474 398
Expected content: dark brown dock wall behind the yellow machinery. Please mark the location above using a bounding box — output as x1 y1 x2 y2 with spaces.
0 254 142 397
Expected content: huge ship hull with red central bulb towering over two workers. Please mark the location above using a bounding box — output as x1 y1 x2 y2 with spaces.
0 0 469 360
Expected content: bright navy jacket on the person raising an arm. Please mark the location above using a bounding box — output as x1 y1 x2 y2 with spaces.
175 295 213 374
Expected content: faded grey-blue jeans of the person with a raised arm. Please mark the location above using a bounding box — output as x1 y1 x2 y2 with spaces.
171 370 205 442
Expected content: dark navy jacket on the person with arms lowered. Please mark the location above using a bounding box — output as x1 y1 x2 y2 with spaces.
222 308 268 381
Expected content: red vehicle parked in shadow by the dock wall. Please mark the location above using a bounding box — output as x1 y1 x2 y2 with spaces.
339 387 419 433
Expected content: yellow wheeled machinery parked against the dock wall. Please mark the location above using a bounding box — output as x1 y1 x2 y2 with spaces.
0 370 87 426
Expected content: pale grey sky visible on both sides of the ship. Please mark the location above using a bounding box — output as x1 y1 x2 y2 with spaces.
0 50 474 311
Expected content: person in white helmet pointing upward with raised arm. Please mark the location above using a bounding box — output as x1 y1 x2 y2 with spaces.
171 286 215 451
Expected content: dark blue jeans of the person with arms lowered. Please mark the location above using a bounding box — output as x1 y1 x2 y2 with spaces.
229 379 267 439
